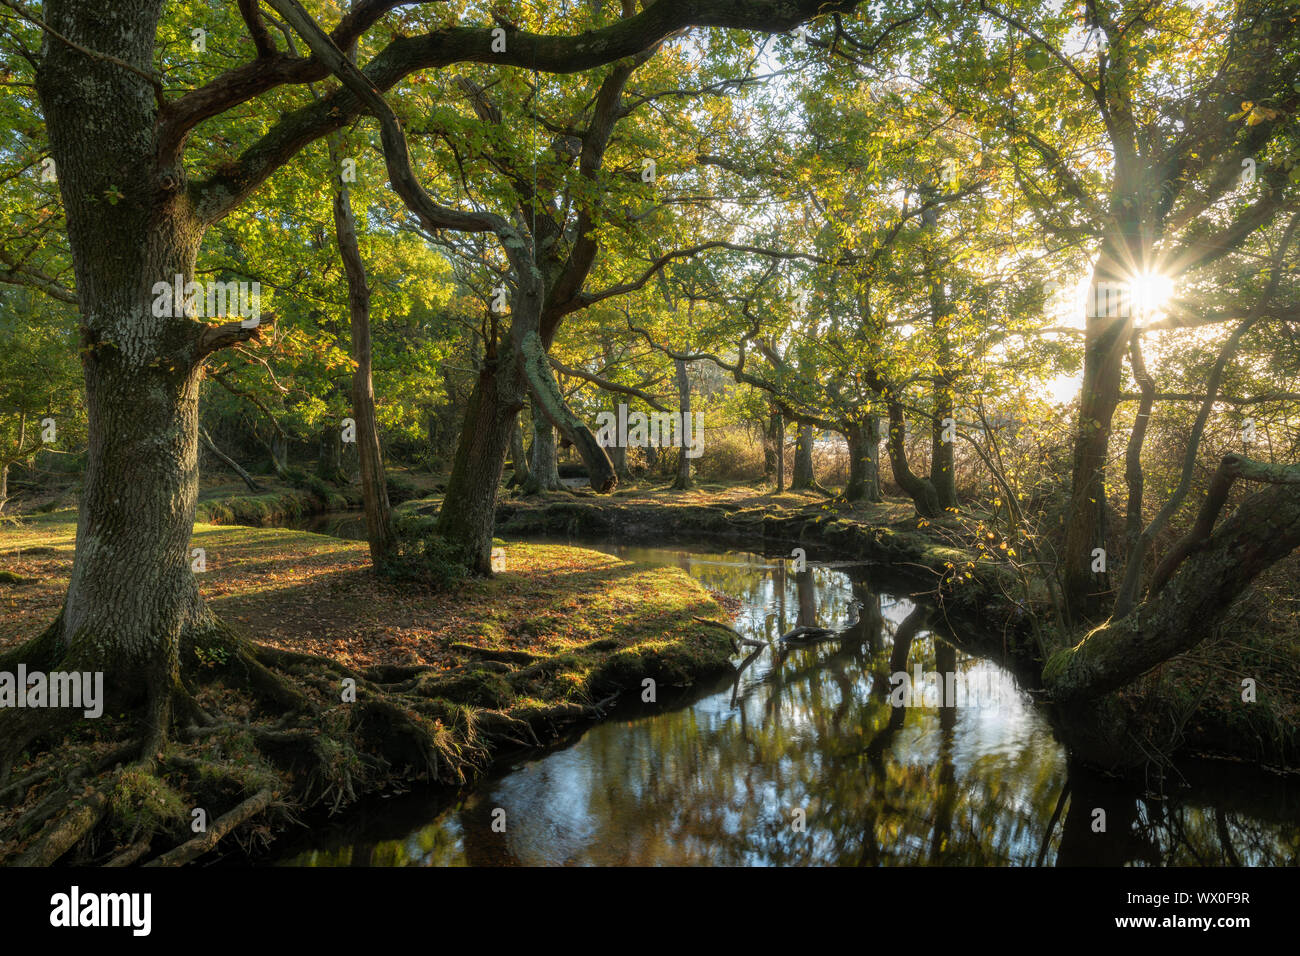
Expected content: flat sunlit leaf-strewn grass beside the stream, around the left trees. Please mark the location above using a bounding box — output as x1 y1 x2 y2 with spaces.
0 512 725 706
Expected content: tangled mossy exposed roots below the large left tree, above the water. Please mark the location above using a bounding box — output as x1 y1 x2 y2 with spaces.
0 600 647 866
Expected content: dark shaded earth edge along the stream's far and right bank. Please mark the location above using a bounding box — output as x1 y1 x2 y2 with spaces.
497 498 1300 774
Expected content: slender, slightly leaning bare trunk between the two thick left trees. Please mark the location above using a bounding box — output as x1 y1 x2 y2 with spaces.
329 137 393 567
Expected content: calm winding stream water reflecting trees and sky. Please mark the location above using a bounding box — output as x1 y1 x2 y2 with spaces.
268 514 1300 866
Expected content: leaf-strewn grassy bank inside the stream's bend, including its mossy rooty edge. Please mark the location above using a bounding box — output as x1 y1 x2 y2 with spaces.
0 512 732 862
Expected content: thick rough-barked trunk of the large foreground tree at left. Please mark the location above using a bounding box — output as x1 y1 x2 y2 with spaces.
22 0 245 749
